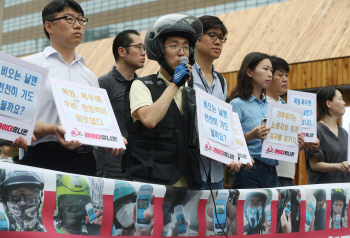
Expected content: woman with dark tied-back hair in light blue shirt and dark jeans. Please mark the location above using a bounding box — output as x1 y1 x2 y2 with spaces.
230 52 278 189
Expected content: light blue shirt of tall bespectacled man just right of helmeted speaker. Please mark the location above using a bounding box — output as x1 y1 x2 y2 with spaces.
192 62 227 183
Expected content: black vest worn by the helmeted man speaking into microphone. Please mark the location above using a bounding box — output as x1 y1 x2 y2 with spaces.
124 74 201 188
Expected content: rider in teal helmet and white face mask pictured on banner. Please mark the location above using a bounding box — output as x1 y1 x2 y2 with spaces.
111 180 154 236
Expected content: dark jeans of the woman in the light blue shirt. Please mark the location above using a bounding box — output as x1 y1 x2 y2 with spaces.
231 159 277 189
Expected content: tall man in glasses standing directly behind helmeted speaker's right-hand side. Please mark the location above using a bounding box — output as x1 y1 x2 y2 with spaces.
188 16 243 189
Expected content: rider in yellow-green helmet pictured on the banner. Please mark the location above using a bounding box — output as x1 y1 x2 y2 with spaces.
56 175 102 235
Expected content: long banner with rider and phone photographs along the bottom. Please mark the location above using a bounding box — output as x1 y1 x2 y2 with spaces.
0 163 350 238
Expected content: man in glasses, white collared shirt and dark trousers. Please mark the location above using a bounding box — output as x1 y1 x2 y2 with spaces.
20 0 122 176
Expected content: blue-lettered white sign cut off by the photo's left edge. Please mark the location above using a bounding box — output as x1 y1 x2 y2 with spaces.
0 52 49 145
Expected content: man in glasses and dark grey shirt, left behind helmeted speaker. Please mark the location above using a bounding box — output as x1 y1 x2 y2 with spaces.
95 30 146 180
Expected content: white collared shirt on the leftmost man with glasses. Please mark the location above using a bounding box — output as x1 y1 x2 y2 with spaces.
23 46 99 146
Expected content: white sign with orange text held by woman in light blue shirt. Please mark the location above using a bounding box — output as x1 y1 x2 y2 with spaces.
261 102 304 163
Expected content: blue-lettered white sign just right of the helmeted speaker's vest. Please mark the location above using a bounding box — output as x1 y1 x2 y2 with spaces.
195 87 247 164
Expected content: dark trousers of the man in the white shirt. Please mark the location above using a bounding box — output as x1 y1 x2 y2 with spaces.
19 142 96 176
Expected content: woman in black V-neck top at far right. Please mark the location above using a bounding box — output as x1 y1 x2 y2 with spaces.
305 86 350 184
